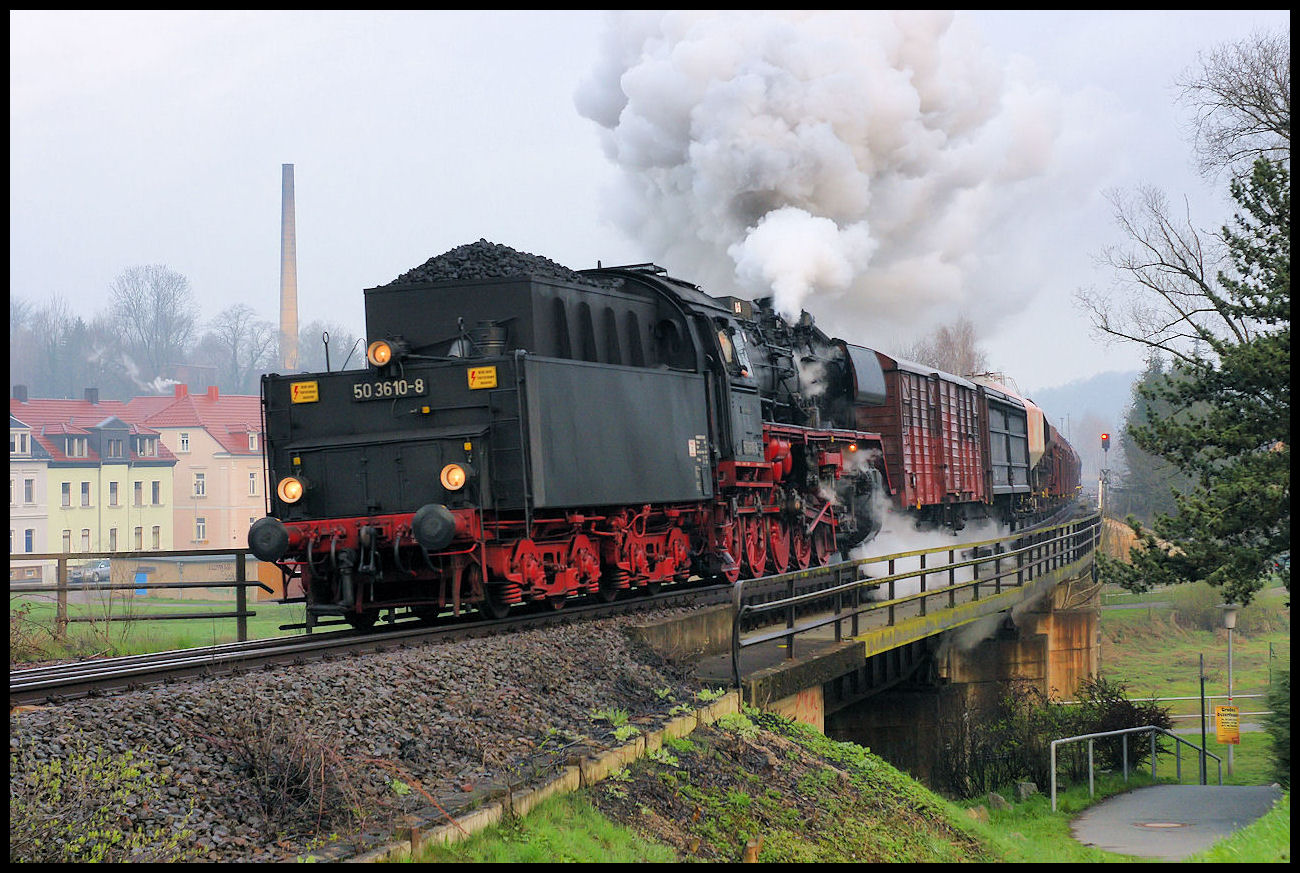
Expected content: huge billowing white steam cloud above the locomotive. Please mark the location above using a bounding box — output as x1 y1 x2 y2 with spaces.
576 12 1088 342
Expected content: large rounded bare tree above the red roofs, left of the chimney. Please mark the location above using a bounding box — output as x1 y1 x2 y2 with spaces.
109 264 199 381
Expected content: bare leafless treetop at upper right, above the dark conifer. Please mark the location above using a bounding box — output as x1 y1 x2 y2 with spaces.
1178 31 1291 175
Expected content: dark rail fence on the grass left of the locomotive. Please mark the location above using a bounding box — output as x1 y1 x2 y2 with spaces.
9 547 272 642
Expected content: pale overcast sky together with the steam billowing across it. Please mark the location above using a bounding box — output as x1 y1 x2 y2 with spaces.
9 12 1290 391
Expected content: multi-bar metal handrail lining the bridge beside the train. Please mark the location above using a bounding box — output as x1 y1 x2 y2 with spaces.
732 513 1100 687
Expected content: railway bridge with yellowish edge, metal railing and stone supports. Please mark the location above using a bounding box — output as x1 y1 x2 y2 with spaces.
641 513 1101 777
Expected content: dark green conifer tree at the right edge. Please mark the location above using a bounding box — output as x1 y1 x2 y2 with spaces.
1110 158 1291 603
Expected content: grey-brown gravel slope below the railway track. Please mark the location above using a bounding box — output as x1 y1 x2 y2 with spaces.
9 612 712 861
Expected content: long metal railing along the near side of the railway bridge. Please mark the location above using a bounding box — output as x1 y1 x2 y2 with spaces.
732 513 1101 687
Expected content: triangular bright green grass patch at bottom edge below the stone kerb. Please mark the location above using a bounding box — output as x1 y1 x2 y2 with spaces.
390 794 676 864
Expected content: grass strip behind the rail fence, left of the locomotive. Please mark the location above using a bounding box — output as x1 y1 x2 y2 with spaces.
9 591 304 663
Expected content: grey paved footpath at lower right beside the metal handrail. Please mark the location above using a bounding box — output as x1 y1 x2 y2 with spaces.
1071 785 1282 861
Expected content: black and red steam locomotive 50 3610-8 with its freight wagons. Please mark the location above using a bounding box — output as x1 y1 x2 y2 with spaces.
248 240 1079 627
